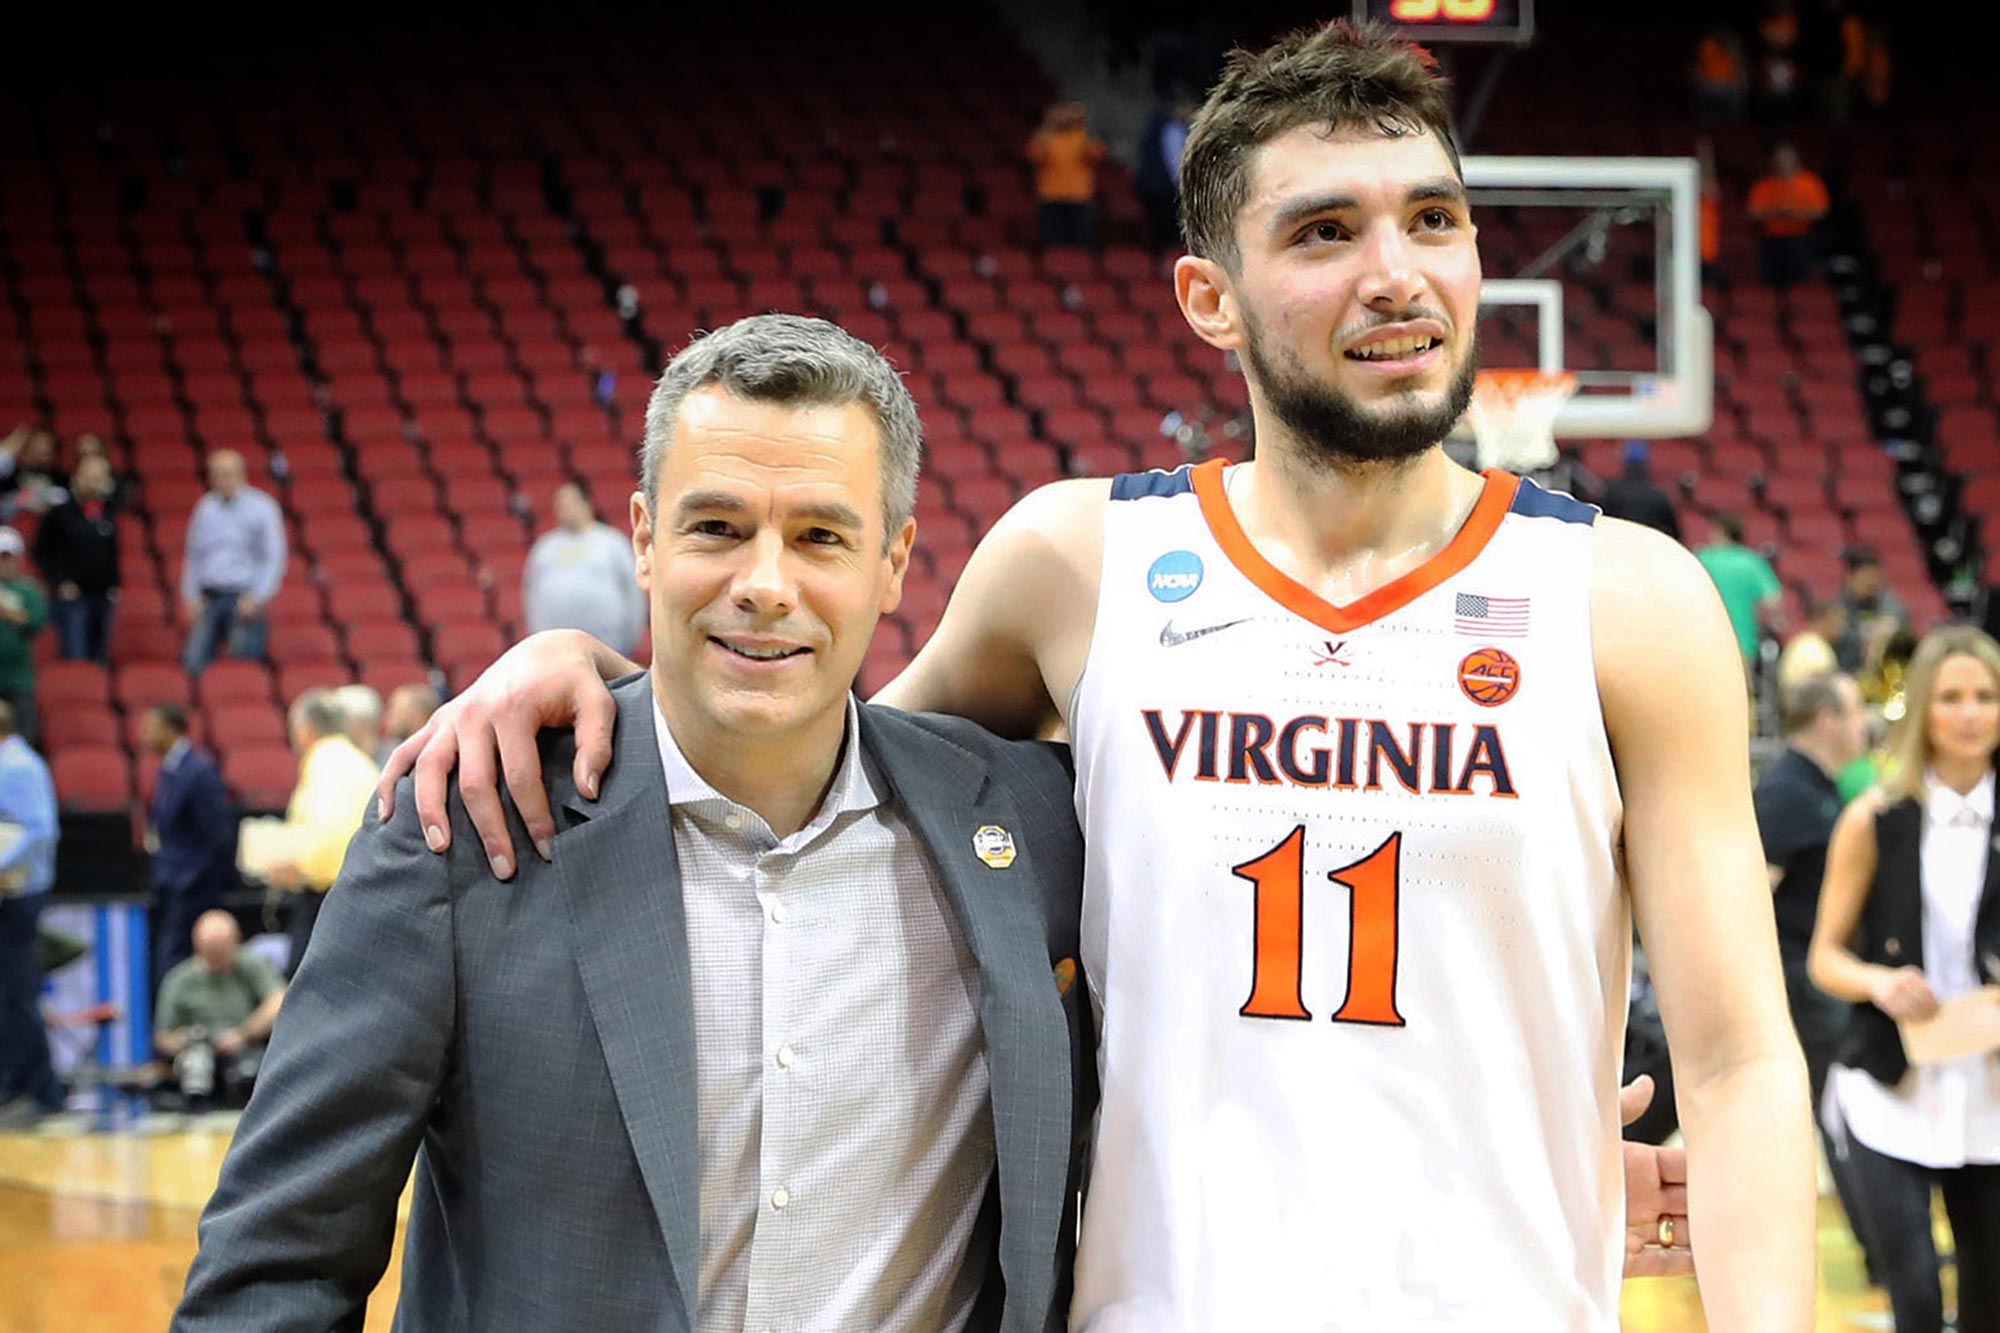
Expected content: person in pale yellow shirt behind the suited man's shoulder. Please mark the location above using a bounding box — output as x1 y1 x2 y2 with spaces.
266 691 382 971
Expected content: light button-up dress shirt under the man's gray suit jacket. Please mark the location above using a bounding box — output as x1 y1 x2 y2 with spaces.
654 699 996 1333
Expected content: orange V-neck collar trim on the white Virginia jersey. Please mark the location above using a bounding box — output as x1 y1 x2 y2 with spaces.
1186 458 1520 634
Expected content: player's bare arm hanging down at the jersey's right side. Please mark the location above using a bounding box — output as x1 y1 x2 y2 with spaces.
1592 518 1814 1333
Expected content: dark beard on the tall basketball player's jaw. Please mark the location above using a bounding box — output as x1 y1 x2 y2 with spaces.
1244 312 1480 470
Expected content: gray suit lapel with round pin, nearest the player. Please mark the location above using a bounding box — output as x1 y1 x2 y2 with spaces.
860 705 1072 1329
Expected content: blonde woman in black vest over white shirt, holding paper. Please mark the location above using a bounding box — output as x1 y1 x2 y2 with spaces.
1808 626 2000 1333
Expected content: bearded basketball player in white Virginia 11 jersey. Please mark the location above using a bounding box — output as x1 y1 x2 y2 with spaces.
392 24 1814 1333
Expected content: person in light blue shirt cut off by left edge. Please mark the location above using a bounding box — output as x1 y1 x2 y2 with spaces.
0 703 62 1127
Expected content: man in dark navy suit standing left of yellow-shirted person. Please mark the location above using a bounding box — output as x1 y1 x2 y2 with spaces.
144 705 238 977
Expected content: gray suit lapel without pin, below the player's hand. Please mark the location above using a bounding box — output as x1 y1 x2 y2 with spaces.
554 675 700 1325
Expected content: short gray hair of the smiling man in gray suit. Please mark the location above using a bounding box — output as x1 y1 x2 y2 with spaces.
640 314 924 536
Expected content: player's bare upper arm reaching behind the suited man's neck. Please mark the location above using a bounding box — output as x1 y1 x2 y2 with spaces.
874 480 1110 739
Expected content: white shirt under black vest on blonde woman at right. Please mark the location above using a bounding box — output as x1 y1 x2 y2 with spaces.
1832 773 2000 1167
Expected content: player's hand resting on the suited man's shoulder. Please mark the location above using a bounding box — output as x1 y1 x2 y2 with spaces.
376 630 622 879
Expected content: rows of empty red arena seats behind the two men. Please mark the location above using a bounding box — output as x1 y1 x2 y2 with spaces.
0 6 1936 820
